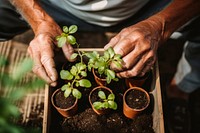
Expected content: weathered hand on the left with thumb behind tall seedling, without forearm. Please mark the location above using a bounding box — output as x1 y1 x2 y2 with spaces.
28 23 73 86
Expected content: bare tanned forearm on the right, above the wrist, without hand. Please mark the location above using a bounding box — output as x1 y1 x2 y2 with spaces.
150 0 200 42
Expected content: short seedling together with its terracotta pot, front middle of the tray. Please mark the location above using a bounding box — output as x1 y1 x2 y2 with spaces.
89 86 117 115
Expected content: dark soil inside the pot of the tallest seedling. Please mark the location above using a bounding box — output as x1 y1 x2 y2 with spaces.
54 91 76 109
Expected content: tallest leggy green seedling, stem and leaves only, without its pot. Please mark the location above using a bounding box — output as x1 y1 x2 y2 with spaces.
56 25 91 99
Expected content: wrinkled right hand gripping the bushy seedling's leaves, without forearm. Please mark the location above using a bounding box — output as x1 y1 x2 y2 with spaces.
104 19 163 78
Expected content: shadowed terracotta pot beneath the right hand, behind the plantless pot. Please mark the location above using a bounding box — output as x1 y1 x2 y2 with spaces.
125 72 149 88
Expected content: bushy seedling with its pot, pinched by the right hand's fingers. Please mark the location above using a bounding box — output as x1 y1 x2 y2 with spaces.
86 47 122 86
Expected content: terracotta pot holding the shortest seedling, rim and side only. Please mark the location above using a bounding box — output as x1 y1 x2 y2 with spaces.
89 86 112 115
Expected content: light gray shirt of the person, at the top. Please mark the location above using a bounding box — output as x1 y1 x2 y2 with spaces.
49 0 149 26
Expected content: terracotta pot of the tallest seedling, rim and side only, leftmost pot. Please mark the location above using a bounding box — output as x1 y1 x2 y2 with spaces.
51 89 78 117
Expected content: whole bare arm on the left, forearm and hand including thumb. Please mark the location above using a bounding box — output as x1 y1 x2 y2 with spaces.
10 0 73 86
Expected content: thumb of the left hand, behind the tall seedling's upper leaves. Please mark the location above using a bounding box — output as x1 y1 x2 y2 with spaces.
62 44 74 61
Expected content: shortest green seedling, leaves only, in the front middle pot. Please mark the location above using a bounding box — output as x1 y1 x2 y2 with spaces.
93 91 117 110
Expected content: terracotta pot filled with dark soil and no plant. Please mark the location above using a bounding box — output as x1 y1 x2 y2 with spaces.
123 87 150 119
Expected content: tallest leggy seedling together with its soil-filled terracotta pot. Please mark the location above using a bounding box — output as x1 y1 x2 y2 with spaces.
51 25 91 117
